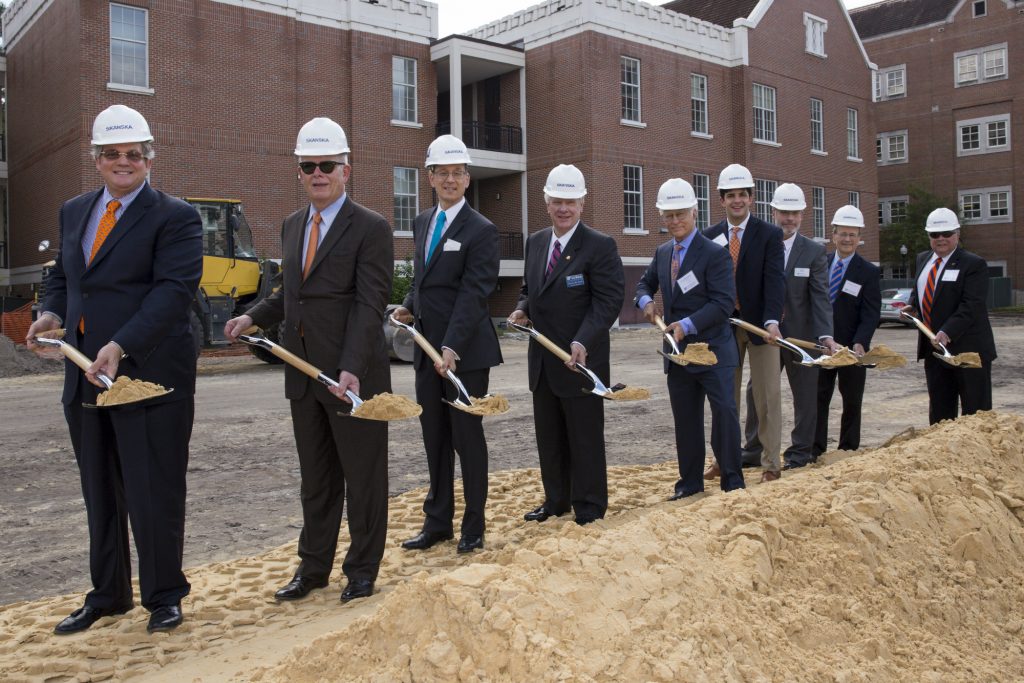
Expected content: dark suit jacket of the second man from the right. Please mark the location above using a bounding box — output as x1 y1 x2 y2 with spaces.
828 252 882 351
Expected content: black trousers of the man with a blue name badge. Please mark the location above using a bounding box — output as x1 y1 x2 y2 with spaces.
534 370 608 522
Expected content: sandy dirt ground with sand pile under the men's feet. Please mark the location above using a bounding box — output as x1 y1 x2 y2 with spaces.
0 324 1024 681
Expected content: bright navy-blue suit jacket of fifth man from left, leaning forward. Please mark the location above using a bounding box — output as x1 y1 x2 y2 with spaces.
633 232 738 373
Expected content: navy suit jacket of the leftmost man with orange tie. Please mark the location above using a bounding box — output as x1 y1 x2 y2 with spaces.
43 183 203 403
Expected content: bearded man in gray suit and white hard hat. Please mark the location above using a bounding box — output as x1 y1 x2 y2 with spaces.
743 182 838 469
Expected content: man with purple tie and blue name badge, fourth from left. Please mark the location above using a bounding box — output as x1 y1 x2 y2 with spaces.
509 164 625 524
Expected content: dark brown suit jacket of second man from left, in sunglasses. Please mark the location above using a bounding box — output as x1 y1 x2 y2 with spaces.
249 198 394 400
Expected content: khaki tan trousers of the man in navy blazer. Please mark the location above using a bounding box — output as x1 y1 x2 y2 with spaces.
732 328 782 472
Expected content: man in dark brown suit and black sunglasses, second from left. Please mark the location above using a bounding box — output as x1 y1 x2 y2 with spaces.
224 118 394 602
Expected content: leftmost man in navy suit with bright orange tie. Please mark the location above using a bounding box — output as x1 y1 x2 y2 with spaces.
28 104 203 634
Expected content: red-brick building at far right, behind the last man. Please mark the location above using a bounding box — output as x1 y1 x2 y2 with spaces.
851 0 1024 300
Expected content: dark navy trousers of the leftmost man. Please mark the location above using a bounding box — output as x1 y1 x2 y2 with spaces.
65 370 195 611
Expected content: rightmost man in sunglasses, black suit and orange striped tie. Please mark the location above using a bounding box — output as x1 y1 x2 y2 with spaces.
907 208 995 425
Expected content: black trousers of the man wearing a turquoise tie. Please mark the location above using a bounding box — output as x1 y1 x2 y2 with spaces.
416 360 490 536
